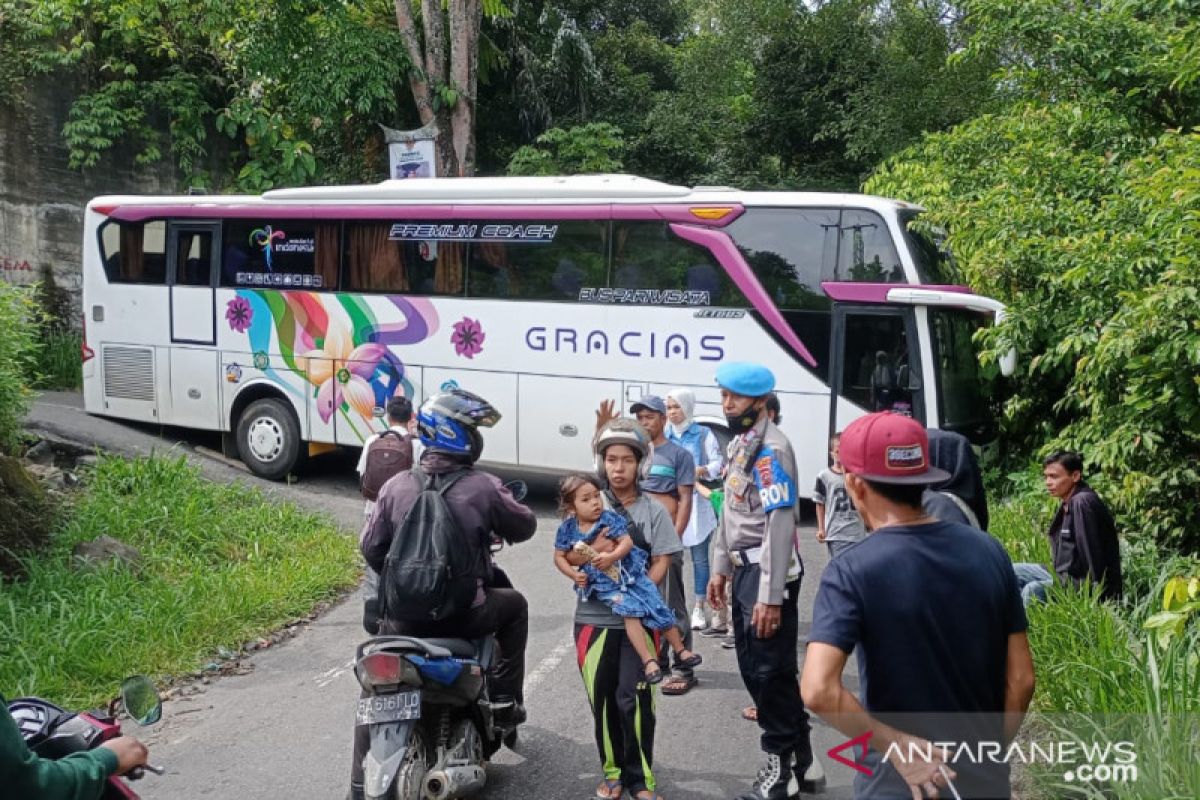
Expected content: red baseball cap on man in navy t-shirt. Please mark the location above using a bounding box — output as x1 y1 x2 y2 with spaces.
839 411 950 485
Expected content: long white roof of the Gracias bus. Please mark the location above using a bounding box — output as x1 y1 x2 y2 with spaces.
89 175 920 211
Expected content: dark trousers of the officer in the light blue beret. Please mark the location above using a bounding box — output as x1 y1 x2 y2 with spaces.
733 565 812 768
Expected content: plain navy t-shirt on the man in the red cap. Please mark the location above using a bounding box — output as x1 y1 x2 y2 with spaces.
808 522 1027 798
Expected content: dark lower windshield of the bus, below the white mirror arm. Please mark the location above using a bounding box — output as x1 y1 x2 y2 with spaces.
929 308 995 444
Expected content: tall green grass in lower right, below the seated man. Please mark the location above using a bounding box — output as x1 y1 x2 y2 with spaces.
991 494 1200 800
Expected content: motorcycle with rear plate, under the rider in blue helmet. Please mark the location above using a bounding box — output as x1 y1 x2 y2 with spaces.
354 481 527 800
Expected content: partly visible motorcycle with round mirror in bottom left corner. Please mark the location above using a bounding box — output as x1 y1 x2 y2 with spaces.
8 675 164 800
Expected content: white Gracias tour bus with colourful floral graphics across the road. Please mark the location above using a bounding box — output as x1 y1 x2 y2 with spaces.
83 175 1010 485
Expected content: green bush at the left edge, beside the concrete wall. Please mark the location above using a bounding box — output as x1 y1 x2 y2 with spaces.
0 283 41 452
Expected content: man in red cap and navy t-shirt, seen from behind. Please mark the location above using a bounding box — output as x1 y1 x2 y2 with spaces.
800 413 1033 798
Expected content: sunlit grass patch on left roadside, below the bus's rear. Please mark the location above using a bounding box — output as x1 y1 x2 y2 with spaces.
0 457 359 708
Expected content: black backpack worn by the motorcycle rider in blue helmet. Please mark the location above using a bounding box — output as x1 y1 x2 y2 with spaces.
379 468 485 622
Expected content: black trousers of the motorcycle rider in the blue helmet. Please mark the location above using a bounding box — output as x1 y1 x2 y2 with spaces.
350 589 529 784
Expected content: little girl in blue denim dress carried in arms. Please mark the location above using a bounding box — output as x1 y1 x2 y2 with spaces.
554 474 703 684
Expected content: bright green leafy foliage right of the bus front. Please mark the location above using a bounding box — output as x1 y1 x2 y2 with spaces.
866 0 1200 552
